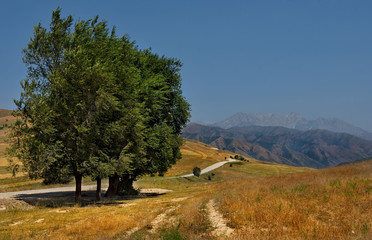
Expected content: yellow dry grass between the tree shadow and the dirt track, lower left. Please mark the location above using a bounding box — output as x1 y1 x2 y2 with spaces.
0 196 174 239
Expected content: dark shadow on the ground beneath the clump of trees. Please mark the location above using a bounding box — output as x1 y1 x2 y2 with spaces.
16 190 166 208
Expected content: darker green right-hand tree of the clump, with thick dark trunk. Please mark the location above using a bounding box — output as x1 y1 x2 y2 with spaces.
106 45 190 196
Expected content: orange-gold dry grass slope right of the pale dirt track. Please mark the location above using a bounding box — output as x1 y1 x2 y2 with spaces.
220 161 372 239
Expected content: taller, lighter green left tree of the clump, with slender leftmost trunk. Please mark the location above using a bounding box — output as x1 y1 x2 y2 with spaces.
12 9 140 201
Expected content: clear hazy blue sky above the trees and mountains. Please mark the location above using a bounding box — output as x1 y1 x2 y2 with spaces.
0 0 372 132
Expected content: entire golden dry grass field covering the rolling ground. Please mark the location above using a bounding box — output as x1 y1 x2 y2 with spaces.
0 130 372 239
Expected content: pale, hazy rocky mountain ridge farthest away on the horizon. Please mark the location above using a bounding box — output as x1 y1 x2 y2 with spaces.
209 112 372 141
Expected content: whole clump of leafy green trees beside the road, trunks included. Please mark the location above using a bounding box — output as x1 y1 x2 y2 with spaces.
10 8 190 201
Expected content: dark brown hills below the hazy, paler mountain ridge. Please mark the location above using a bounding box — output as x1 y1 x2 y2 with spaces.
183 124 372 168
